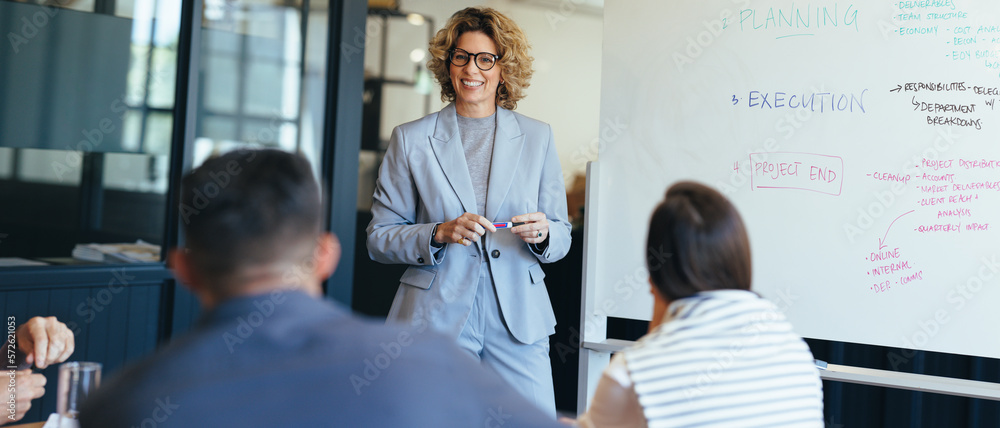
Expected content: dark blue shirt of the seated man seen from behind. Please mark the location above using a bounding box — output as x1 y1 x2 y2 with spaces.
80 291 559 428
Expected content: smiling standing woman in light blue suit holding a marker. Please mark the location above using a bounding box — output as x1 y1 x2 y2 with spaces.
368 7 570 417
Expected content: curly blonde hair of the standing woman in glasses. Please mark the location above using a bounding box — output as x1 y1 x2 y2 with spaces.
427 7 534 110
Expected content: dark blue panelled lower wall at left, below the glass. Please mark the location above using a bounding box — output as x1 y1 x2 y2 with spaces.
0 265 198 422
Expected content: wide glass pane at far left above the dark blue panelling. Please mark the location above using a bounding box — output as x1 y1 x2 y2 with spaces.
0 0 181 264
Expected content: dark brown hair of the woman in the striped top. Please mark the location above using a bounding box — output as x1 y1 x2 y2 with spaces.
646 181 752 301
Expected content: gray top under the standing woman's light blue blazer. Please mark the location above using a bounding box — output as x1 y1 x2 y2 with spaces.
458 112 497 215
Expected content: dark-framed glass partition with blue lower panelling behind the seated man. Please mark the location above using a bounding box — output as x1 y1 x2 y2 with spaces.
0 0 358 423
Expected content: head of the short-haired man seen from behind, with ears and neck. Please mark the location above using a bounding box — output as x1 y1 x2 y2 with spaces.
170 150 340 307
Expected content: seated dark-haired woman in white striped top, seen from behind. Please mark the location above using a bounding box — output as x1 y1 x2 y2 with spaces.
578 182 823 427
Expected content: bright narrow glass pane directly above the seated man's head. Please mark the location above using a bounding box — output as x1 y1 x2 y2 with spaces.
192 0 328 173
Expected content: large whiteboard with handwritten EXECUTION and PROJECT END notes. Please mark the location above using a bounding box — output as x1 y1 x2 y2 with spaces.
591 0 1000 358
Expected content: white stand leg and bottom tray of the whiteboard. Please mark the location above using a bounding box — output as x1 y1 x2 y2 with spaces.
576 162 1000 414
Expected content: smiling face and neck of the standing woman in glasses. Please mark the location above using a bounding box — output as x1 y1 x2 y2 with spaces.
448 31 501 117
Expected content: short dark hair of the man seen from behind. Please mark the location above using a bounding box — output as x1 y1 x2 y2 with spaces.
179 149 322 291
